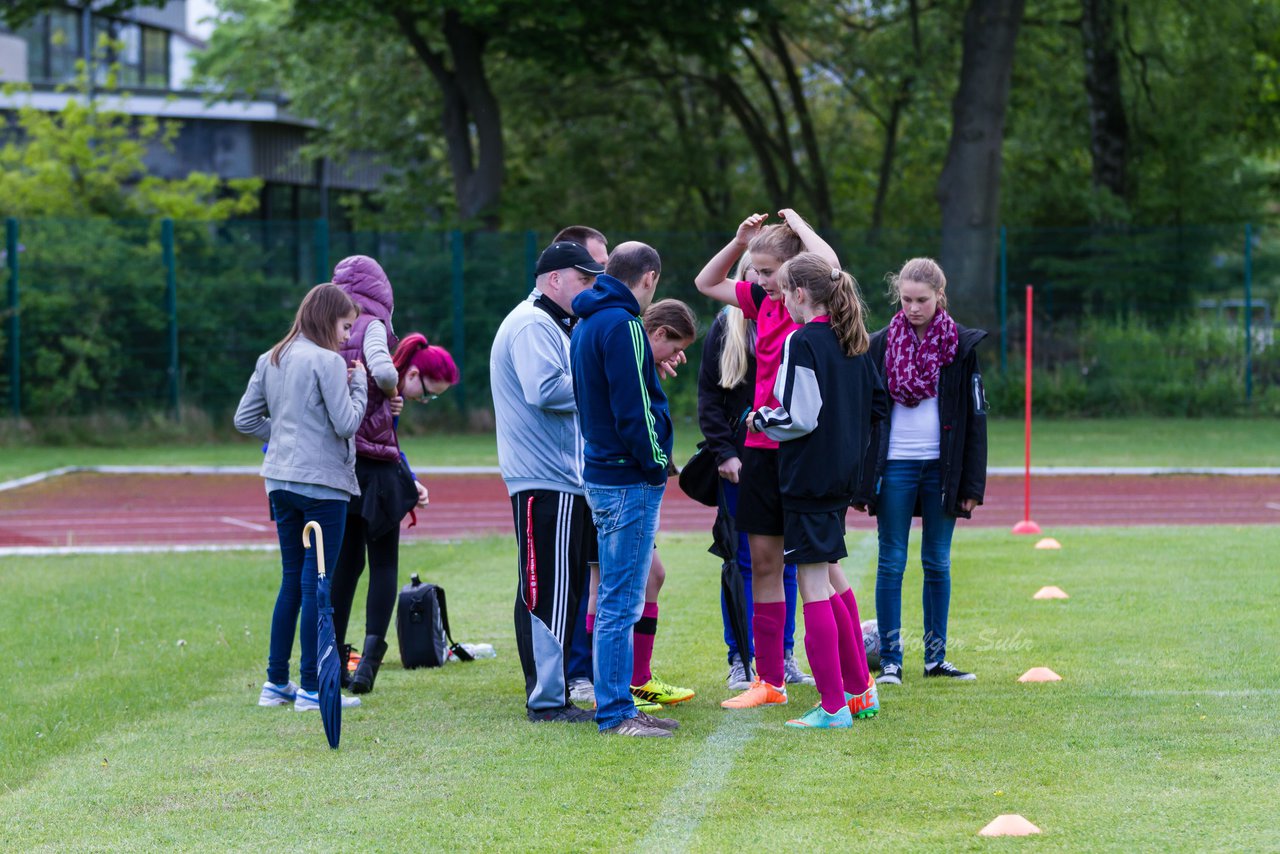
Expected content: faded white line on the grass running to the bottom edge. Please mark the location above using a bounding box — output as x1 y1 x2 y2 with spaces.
636 712 762 851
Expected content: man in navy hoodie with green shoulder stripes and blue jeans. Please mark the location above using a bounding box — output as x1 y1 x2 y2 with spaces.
570 242 678 736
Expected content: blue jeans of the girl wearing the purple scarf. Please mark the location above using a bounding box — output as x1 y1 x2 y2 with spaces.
876 460 956 666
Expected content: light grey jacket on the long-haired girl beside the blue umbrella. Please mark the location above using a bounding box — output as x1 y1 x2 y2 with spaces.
236 335 367 495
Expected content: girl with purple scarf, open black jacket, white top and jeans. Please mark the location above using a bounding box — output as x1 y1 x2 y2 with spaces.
854 257 987 685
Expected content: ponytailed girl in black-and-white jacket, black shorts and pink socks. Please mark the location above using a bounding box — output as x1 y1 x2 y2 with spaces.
748 252 886 729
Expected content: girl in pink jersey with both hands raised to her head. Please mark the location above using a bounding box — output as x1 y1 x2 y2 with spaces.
695 209 873 709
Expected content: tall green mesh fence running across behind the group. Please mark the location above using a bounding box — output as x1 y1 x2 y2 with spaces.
0 219 1280 419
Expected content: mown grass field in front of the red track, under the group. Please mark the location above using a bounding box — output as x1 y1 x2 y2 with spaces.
0 526 1280 851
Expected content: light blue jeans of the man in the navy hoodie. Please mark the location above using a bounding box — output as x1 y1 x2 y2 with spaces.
586 483 667 730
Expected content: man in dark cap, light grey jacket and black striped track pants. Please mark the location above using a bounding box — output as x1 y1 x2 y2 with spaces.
489 241 604 723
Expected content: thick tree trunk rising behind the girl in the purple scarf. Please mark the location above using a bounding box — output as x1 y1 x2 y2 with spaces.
938 0 1025 329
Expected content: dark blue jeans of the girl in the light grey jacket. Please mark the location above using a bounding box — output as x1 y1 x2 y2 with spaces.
266 489 347 691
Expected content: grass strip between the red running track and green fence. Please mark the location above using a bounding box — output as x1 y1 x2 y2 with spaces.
0 419 1280 480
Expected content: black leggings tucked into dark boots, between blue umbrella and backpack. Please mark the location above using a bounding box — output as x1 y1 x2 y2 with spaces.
330 513 399 645
